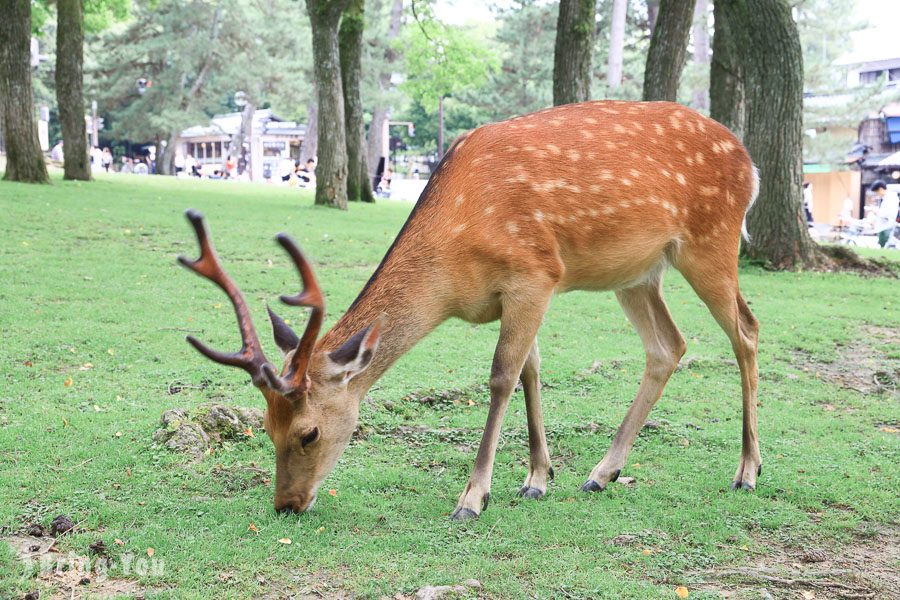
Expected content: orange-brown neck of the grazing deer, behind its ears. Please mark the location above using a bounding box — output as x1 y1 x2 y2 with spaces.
318 248 447 399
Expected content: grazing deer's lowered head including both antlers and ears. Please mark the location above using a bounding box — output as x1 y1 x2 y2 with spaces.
178 210 383 512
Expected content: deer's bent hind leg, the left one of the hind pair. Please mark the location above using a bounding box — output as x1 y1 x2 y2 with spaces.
581 279 685 492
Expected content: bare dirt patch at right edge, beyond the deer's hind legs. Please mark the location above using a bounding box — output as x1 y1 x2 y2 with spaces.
794 325 900 394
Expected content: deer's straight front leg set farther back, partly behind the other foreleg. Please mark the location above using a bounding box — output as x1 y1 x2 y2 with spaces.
519 340 553 498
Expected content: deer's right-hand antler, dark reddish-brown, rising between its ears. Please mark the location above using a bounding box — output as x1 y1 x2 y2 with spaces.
263 233 325 394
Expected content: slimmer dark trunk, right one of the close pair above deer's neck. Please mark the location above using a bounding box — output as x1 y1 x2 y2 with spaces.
338 0 375 202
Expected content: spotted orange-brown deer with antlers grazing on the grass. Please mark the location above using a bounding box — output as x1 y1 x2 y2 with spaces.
179 101 762 520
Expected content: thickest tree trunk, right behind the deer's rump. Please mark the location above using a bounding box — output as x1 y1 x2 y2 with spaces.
723 0 821 269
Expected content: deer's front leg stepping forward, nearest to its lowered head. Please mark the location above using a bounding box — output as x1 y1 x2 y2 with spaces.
450 288 552 520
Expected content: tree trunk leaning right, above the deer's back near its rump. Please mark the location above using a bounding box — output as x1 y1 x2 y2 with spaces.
644 0 694 102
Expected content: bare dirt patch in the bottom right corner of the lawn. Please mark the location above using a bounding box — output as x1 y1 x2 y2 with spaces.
694 525 900 599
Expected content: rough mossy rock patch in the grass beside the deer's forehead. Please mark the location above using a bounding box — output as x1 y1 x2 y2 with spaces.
153 404 263 461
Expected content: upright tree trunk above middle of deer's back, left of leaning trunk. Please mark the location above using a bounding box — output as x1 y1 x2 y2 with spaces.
553 0 595 106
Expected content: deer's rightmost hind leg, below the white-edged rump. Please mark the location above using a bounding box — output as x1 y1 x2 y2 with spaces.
676 249 762 491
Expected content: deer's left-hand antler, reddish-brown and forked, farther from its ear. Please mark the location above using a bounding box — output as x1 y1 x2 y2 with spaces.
178 209 267 383
